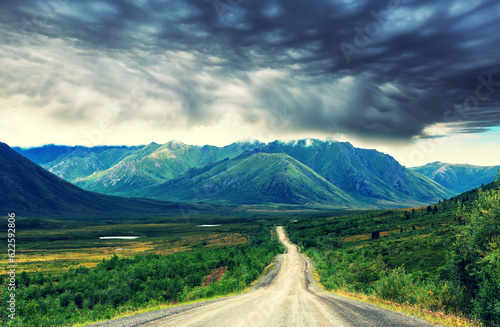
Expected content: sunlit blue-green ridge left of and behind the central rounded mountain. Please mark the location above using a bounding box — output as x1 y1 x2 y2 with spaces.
14 141 259 196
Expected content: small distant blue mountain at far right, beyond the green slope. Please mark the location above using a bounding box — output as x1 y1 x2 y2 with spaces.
411 161 500 193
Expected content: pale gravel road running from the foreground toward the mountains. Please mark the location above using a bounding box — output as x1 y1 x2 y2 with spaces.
93 227 431 327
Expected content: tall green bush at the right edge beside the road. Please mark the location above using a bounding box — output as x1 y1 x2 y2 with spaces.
449 176 500 326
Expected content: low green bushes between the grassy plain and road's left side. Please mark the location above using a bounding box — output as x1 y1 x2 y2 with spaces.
0 223 283 326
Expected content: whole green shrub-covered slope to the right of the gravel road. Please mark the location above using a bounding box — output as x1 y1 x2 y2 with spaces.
288 178 500 326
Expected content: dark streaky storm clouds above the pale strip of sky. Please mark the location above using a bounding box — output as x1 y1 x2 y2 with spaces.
0 0 500 138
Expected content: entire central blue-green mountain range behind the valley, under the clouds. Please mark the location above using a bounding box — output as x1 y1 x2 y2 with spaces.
11 139 455 208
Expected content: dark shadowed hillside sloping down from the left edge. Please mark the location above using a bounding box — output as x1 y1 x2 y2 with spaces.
0 142 186 216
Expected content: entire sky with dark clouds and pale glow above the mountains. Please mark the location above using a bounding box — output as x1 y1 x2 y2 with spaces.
0 0 500 166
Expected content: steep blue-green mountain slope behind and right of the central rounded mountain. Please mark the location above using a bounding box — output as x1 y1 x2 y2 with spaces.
260 139 454 205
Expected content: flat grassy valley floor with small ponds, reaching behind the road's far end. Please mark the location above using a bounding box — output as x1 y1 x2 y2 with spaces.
0 205 363 276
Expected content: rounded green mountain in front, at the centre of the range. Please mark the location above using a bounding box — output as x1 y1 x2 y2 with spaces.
137 152 359 208
